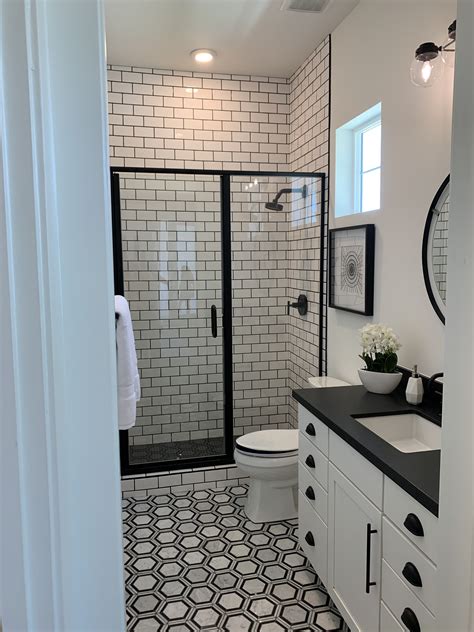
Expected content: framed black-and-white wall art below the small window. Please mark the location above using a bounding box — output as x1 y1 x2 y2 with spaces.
329 224 375 316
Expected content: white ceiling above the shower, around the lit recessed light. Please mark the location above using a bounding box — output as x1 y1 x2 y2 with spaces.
105 0 359 77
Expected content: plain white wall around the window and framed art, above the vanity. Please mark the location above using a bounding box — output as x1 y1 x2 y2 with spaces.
328 0 456 383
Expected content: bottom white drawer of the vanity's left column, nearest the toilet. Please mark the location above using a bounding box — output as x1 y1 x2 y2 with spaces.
298 492 328 584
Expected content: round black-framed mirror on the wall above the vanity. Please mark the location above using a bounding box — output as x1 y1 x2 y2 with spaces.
422 176 449 324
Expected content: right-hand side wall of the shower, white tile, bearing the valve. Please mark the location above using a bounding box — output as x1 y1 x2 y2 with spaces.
288 37 330 426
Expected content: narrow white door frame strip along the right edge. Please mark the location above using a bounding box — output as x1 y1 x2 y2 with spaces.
438 0 474 632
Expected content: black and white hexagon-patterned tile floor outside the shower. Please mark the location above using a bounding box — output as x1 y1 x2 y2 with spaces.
123 487 348 632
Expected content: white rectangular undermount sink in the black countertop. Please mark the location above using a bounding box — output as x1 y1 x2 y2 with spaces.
354 413 441 452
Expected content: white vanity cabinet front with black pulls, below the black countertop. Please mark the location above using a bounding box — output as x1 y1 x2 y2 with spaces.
298 405 438 632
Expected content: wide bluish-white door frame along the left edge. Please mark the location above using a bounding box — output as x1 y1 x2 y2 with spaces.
0 0 125 632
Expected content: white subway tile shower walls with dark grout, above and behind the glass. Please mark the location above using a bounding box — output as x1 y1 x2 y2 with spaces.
108 39 330 478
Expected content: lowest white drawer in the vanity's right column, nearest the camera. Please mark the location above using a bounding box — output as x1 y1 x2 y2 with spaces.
382 561 435 632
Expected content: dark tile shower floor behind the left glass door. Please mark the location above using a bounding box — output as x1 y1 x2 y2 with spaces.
129 437 225 465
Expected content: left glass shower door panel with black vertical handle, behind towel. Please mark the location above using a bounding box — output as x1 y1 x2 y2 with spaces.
114 171 225 469
